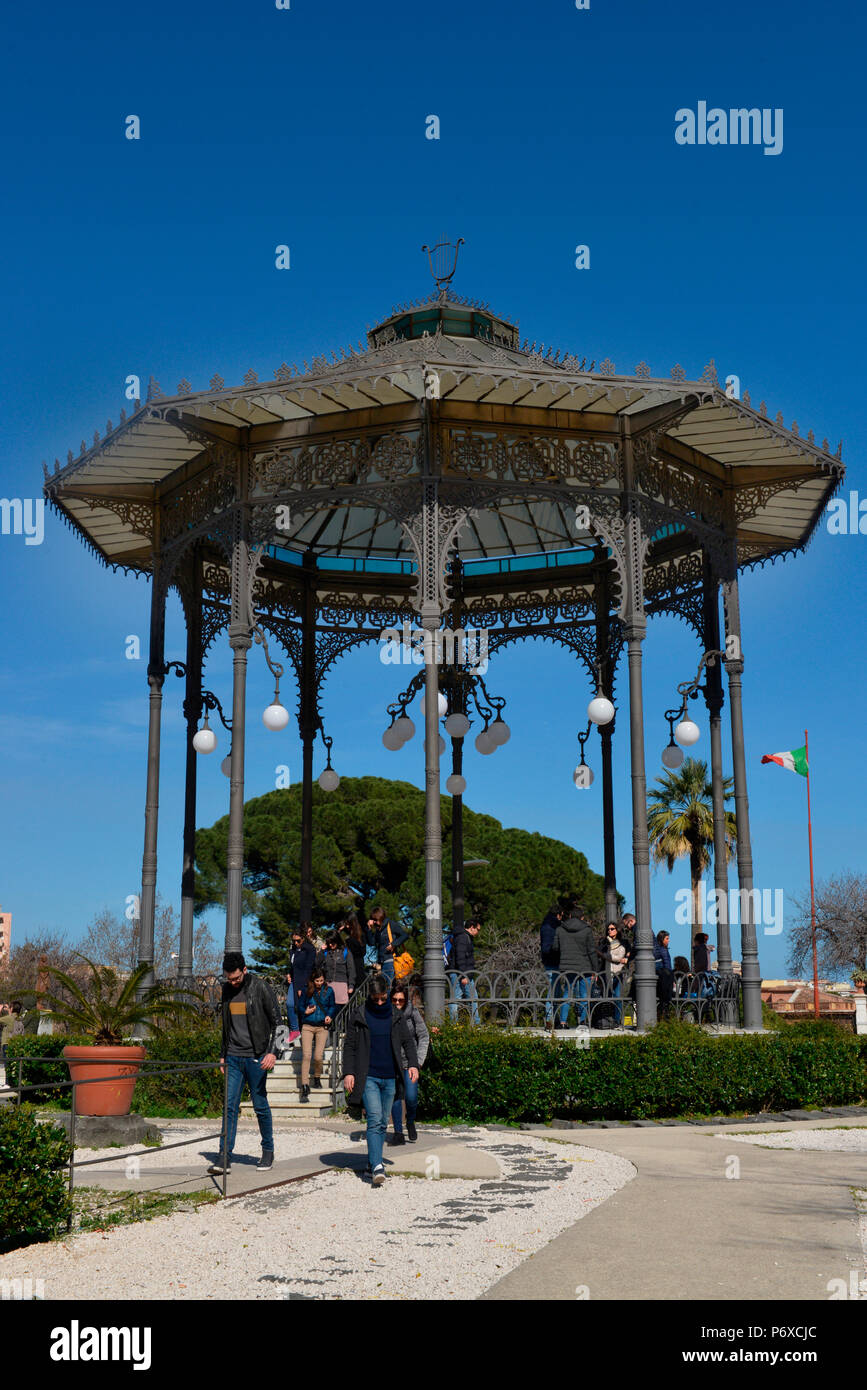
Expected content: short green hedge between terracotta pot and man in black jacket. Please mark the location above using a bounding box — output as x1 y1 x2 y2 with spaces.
132 1024 222 1119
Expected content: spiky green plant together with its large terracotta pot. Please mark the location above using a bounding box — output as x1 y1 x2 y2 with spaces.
39 956 193 1115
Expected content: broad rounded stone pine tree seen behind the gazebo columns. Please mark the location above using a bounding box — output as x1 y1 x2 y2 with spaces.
196 777 604 966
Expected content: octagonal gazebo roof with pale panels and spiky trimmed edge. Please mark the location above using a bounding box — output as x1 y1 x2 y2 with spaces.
44 291 843 570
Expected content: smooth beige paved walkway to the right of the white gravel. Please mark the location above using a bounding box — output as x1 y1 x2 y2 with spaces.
484 1119 867 1304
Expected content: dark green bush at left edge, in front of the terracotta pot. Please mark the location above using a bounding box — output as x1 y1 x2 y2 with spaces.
0 1106 71 1251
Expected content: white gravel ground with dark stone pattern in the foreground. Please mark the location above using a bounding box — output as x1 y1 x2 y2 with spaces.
0 1126 635 1301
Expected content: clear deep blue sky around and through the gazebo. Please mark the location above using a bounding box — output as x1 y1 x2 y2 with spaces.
0 0 867 976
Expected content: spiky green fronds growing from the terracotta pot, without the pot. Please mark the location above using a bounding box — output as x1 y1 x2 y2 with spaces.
38 955 196 1047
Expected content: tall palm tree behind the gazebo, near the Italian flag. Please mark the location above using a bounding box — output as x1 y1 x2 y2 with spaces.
647 758 738 950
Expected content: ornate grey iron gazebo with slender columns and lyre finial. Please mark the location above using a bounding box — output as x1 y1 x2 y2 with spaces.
43 247 843 1029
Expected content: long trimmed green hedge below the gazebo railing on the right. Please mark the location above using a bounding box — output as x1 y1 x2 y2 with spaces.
418 1023 867 1123
